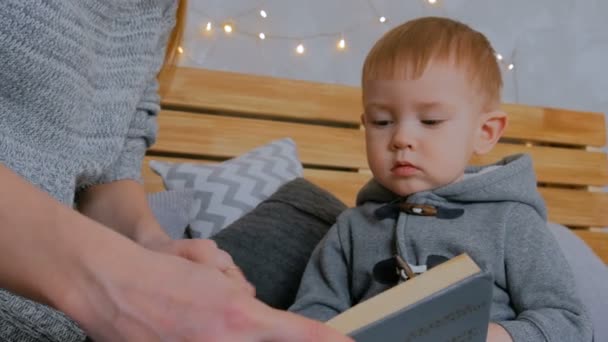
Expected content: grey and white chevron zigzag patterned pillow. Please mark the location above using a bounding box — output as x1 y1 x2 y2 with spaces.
150 138 302 238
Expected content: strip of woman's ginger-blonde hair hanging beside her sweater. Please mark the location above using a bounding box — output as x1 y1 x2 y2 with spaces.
158 0 188 97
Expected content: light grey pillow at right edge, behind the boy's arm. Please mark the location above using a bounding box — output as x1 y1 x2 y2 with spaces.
548 223 608 341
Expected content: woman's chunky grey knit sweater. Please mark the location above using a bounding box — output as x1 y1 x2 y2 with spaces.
0 0 176 342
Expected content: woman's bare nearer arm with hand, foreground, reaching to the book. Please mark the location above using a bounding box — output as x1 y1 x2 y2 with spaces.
0 164 347 341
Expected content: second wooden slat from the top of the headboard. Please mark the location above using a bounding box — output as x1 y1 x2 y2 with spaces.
153 111 608 186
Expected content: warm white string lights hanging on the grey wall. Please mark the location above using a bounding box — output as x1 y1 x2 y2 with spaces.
184 0 515 71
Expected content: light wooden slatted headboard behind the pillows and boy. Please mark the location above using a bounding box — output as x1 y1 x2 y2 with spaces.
143 68 608 263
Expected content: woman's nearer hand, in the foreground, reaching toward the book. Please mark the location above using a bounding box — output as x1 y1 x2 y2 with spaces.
64 241 350 342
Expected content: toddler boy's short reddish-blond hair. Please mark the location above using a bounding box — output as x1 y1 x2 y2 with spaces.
361 17 502 109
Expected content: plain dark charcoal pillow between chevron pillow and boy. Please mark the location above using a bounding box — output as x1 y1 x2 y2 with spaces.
212 178 346 310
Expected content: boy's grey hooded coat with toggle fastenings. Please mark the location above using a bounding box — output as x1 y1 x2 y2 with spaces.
290 155 592 342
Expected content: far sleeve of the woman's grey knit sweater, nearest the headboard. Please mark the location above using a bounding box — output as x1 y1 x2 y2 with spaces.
99 1 177 184
